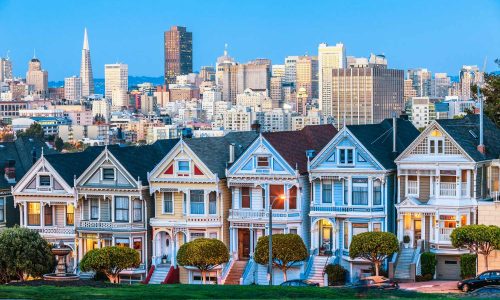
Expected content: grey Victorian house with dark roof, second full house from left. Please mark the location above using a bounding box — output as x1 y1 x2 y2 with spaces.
76 140 177 281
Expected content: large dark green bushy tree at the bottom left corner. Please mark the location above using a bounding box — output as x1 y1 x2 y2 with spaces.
0 227 55 282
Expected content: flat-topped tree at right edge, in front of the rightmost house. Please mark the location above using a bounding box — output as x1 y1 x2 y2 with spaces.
450 225 500 270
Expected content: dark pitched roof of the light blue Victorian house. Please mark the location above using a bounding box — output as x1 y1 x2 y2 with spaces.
346 118 420 170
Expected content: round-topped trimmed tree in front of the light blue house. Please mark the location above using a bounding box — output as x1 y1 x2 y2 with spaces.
349 232 399 276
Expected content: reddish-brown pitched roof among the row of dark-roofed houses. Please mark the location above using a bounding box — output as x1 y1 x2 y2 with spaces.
262 124 337 174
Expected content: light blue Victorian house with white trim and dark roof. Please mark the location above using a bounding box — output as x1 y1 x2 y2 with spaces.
305 118 419 282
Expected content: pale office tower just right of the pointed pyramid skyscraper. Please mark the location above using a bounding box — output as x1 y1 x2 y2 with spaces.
104 63 128 107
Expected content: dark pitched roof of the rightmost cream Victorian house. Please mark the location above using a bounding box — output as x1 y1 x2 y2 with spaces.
436 115 500 161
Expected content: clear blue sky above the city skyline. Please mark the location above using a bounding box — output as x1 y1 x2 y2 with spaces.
0 0 500 80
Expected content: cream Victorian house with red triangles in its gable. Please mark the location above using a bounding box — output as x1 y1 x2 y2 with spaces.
148 132 257 283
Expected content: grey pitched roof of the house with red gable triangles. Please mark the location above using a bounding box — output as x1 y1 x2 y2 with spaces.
184 131 258 178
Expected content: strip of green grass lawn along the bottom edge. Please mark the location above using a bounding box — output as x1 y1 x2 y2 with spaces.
0 285 458 300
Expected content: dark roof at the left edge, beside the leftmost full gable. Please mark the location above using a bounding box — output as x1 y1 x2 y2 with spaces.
0 137 56 189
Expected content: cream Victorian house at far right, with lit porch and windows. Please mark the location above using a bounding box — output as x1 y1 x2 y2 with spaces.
396 115 500 279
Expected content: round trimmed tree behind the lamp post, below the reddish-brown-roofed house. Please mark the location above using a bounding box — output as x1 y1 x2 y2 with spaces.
254 233 308 281
